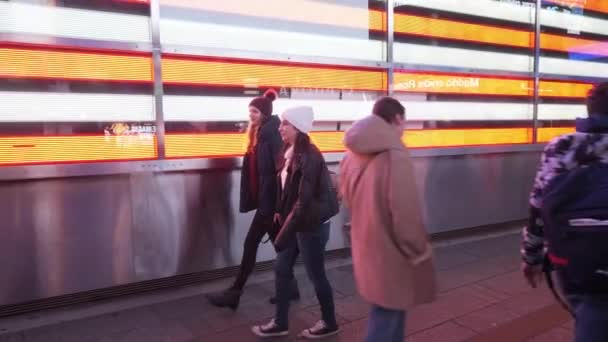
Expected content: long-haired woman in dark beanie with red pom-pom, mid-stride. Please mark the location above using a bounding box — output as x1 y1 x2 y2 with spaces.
207 89 299 310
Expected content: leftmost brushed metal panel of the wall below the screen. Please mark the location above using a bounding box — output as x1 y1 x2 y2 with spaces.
0 176 133 304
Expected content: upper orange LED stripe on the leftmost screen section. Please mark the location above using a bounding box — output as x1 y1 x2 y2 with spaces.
0 47 152 82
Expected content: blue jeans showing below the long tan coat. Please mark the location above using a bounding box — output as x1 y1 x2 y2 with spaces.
365 304 406 342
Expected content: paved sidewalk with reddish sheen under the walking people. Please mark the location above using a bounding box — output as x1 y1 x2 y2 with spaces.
0 236 573 342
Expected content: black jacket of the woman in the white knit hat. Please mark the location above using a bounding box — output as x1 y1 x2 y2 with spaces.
270 143 339 251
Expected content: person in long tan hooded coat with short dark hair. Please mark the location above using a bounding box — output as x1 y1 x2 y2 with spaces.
339 97 436 342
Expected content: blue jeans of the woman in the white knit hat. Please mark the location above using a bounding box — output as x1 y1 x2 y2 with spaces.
275 222 337 329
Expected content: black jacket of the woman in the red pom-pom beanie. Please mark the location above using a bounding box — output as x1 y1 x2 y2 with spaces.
240 116 283 216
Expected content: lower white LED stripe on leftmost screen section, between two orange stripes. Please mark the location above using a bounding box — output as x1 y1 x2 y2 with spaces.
0 92 154 122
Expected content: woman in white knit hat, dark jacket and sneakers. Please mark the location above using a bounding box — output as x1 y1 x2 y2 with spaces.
252 106 339 339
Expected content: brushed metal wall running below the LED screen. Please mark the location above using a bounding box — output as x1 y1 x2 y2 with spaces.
0 151 539 305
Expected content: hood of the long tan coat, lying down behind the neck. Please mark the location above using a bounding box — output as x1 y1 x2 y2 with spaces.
344 115 403 154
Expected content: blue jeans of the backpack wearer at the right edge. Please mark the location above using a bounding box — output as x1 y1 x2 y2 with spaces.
568 295 608 342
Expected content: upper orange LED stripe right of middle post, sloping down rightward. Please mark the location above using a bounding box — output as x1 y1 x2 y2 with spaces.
395 14 605 55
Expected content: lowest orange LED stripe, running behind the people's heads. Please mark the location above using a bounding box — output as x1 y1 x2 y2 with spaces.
0 127 574 166
